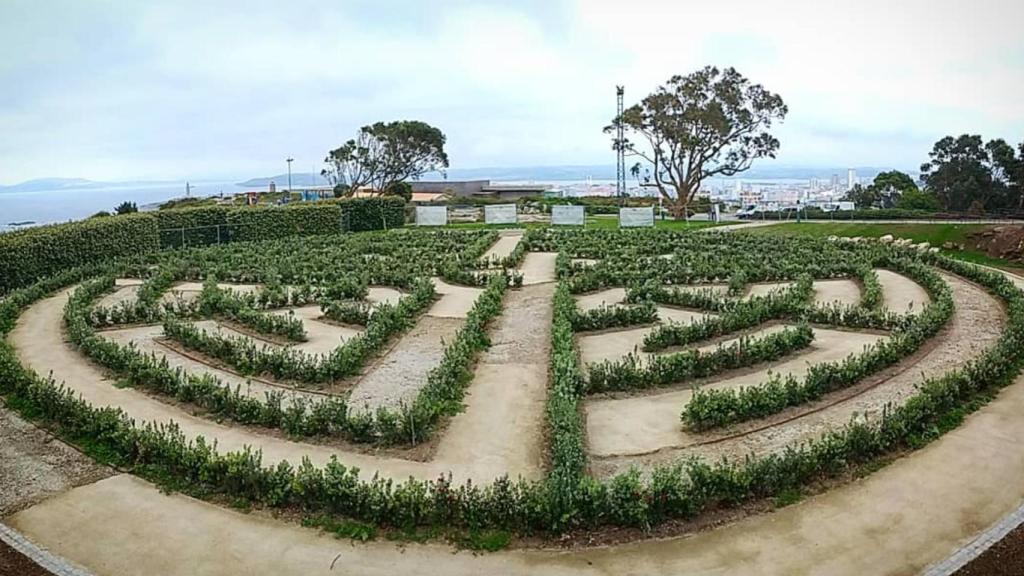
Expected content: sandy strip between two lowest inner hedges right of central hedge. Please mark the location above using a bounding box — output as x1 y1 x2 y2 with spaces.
584 329 882 457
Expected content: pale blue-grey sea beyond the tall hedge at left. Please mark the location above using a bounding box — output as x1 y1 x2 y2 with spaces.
0 181 238 230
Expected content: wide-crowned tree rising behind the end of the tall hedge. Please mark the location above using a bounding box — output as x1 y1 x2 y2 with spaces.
321 120 449 195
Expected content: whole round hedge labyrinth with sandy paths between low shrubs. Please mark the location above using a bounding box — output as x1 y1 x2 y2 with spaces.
0 205 1024 547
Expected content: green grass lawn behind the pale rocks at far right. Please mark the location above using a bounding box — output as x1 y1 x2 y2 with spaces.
751 222 1022 269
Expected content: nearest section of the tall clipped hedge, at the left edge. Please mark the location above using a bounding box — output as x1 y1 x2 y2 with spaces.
0 213 160 292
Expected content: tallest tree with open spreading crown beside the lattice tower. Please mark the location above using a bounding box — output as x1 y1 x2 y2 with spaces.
605 67 787 217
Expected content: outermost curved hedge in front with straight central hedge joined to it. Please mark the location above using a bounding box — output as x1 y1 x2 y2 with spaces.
0 243 1024 533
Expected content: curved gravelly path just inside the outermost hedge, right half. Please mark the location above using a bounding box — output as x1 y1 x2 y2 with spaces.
588 273 1006 476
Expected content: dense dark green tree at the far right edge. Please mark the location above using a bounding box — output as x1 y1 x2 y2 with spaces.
921 134 1024 212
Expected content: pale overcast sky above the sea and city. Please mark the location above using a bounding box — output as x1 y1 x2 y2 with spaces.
0 0 1024 183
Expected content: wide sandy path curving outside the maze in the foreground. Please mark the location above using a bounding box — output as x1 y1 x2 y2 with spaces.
18 368 1024 576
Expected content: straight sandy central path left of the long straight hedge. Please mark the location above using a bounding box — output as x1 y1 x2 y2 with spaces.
434 284 555 478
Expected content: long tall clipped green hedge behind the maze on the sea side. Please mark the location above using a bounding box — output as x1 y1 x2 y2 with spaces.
0 197 406 294
